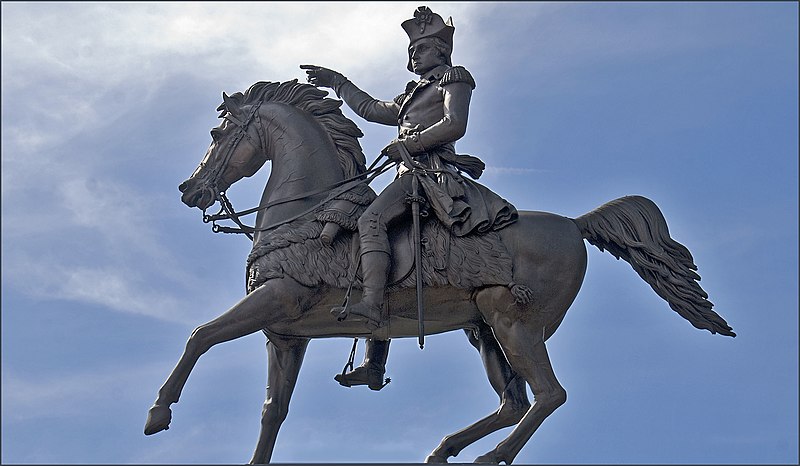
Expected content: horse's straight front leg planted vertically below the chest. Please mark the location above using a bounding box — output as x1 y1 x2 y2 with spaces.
250 335 309 464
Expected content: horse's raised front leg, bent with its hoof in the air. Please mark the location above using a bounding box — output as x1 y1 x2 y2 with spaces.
144 279 302 435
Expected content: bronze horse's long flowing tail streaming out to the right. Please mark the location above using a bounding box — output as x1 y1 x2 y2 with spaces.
575 196 736 337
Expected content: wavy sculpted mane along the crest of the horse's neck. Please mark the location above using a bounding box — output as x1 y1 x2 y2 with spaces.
219 79 366 178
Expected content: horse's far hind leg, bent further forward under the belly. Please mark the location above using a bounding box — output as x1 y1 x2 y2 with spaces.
425 324 530 463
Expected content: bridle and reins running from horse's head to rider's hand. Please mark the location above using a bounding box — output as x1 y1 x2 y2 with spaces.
195 96 396 241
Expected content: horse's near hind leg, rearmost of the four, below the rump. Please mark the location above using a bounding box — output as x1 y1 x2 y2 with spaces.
475 290 567 464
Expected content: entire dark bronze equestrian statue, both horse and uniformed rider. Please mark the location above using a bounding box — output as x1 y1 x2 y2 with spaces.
145 7 735 464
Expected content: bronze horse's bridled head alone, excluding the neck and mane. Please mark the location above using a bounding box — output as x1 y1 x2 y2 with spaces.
178 93 267 210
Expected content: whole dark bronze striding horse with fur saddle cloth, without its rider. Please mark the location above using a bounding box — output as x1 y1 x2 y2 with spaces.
144 80 736 464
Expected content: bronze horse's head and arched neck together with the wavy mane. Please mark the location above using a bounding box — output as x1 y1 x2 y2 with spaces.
178 79 366 210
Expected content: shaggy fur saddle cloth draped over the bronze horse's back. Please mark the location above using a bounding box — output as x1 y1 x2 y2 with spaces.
247 184 513 293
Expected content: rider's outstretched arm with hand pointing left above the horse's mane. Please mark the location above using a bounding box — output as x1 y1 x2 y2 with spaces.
300 65 400 126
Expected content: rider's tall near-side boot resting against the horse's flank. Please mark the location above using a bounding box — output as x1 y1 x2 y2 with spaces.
332 251 389 330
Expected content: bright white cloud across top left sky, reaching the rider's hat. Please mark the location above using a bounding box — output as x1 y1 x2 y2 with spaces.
3 2 471 89
